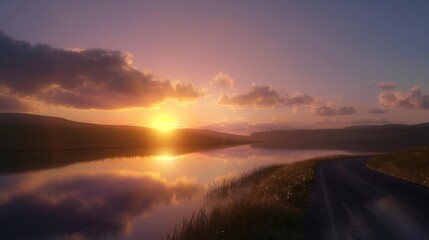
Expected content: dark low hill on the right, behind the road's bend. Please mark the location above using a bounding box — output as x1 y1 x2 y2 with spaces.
250 123 429 151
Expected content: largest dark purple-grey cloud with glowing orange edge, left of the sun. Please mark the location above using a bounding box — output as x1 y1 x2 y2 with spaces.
0 32 204 110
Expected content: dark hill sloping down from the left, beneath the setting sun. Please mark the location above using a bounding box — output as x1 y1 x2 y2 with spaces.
0 113 251 152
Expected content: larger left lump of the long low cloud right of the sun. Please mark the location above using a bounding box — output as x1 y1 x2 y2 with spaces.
218 85 284 108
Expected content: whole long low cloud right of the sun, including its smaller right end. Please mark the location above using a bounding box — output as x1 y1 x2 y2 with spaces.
218 85 315 108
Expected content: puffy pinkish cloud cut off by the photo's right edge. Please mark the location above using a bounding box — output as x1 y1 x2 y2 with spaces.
378 86 429 109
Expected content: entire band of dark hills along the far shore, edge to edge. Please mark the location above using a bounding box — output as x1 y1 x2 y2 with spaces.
0 113 429 152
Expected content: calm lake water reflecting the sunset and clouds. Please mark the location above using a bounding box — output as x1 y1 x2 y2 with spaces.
0 145 358 239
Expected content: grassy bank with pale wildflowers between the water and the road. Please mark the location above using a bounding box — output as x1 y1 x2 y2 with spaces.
167 156 354 240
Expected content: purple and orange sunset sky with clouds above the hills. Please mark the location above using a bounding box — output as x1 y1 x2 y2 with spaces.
0 0 429 134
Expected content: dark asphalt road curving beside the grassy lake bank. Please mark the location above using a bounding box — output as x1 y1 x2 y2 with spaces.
309 158 429 240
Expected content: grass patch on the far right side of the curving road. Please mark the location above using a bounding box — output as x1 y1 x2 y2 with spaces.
367 147 429 187
